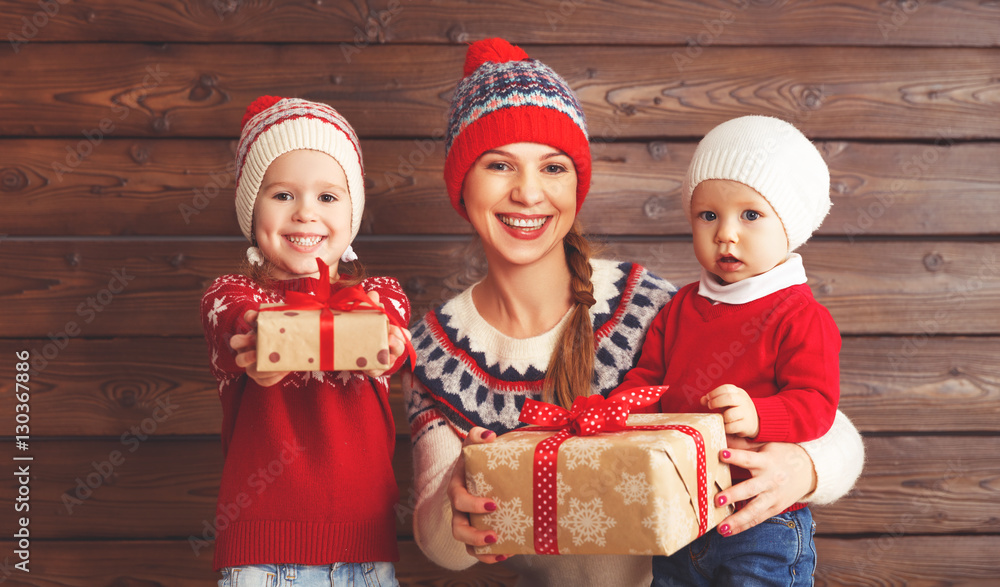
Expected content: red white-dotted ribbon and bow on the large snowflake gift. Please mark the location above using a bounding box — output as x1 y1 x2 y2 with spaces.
520 386 708 554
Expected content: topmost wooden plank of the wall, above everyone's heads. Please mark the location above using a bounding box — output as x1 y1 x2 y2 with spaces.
0 0 1000 46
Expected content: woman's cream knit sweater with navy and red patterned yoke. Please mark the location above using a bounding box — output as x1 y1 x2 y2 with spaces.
403 260 864 587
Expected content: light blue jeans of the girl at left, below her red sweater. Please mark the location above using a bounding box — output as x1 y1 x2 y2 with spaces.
219 562 399 587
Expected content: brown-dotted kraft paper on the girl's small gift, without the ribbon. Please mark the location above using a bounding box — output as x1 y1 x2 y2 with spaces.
257 304 390 371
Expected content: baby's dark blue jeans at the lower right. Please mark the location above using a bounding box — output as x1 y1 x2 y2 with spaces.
652 508 816 587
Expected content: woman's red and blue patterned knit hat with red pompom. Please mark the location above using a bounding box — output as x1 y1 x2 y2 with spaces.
444 39 590 220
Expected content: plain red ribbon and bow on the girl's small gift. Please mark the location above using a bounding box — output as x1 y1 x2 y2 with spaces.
260 257 417 371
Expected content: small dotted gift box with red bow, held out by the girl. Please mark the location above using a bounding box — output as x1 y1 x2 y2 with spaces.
257 258 390 371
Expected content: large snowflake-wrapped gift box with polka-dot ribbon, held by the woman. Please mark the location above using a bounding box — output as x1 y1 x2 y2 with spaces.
464 387 731 555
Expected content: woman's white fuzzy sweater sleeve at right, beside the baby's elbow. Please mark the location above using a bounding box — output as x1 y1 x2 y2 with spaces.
800 410 865 505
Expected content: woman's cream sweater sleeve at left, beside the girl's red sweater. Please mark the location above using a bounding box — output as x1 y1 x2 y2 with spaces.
403 373 477 571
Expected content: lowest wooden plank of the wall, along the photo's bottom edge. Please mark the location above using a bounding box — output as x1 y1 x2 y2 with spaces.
0 535 1000 587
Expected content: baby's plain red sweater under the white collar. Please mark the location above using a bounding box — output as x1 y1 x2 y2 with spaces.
613 283 840 442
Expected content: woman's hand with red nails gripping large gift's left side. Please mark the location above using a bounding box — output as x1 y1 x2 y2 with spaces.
448 426 507 564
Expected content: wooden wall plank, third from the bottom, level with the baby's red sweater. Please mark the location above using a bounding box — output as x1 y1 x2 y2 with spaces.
0 337 1000 438
